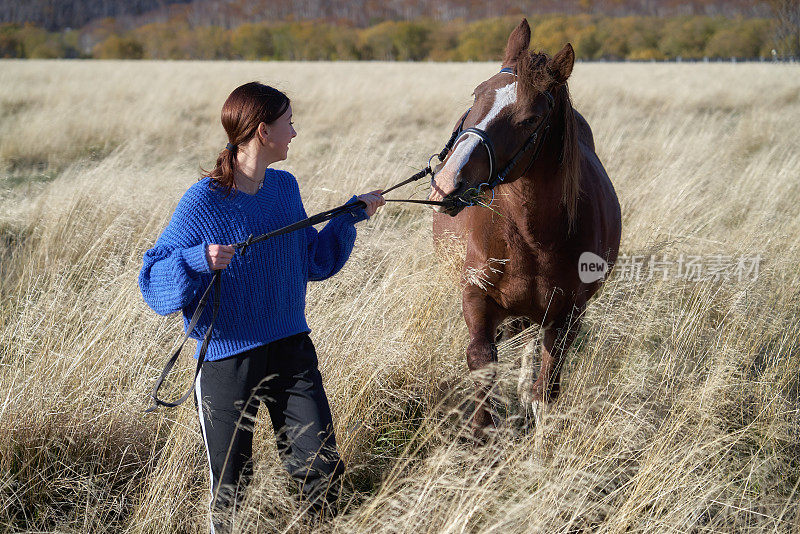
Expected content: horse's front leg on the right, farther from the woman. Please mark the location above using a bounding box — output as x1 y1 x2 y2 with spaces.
531 309 582 425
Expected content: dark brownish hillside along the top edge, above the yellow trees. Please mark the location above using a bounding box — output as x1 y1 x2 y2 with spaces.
0 0 770 31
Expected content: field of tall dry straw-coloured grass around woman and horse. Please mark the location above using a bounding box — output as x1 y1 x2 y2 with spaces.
0 61 800 534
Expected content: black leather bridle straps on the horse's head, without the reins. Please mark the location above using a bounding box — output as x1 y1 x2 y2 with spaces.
428 67 555 206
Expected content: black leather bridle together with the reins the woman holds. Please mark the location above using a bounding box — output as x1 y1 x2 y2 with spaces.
145 68 554 412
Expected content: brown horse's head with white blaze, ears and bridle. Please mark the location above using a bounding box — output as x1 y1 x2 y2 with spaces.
428 19 575 216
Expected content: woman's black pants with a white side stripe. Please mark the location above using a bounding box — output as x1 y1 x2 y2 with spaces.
195 333 344 531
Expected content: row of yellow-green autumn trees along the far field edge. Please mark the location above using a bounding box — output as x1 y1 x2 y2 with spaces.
0 14 800 61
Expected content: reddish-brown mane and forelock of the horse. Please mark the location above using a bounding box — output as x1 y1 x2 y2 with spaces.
516 52 581 229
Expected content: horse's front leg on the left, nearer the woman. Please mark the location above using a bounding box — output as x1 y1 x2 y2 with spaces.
462 294 502 439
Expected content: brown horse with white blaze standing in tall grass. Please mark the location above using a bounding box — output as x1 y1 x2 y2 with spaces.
429 19 622 436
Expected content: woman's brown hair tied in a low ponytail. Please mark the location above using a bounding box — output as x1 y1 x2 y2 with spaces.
203 82 290 196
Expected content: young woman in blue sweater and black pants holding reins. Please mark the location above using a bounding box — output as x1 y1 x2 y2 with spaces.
139 82 385 532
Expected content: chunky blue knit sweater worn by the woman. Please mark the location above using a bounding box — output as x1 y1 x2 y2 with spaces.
139 169 368 361
